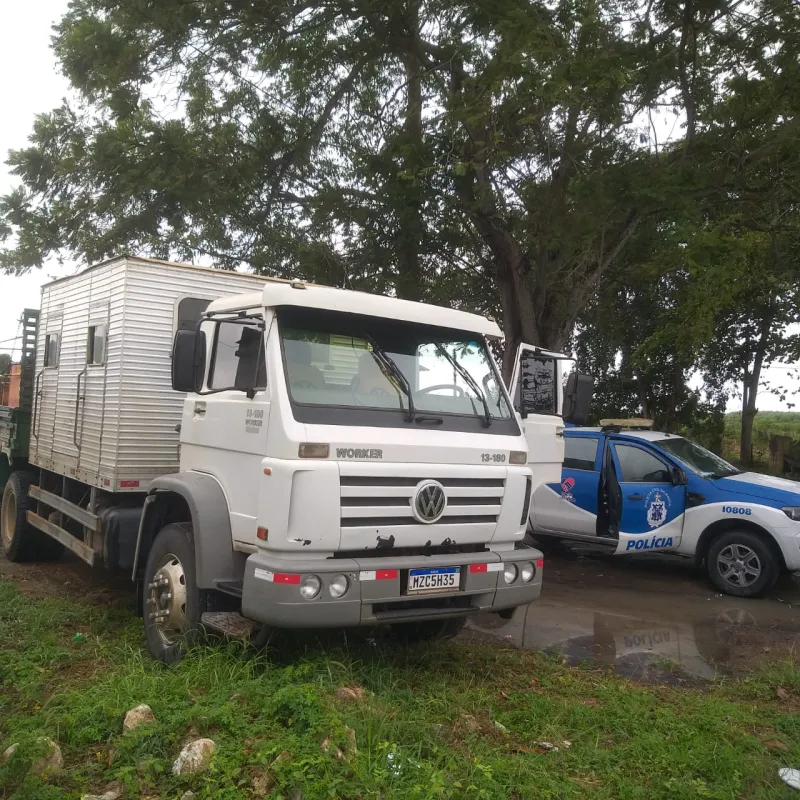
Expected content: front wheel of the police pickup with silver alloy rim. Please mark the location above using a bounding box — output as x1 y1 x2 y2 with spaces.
706 530 781 597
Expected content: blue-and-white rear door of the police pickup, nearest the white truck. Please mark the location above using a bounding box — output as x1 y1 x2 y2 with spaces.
532 431 602 537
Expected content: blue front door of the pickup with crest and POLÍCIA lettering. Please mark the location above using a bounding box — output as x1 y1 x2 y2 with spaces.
607 439 686 553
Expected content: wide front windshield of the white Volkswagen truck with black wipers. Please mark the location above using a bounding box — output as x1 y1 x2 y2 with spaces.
278 308 518 433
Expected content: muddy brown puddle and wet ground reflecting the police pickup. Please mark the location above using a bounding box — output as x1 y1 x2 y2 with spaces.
464 546 800 684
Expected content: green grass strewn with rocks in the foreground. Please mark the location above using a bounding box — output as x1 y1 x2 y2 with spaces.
0 582 800 800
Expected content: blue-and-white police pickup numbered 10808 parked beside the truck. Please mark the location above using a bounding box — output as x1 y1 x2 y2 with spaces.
530 420 800 597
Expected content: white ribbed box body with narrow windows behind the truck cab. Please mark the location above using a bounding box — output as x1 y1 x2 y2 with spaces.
29 257 270 492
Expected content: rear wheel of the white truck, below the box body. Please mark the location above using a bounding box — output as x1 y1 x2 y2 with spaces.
0 471 64 561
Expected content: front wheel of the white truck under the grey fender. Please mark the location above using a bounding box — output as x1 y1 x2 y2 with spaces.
142 522 206 664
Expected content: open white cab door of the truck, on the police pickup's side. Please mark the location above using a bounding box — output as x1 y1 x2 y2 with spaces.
509 344 564 491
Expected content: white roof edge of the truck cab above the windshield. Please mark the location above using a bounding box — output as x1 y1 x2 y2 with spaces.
208 281 502 339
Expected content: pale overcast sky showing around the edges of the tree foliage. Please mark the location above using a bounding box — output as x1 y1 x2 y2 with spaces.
0 6 800 411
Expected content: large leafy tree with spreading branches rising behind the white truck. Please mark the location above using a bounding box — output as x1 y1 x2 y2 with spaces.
0 0 800 374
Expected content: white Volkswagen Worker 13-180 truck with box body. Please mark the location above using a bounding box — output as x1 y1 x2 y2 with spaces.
0 257 580 662
